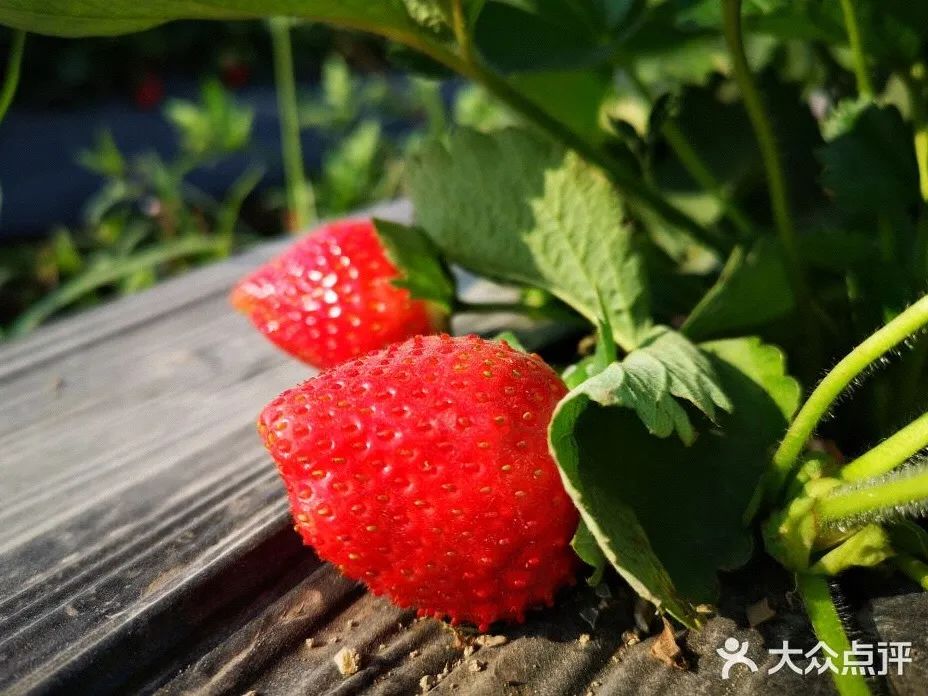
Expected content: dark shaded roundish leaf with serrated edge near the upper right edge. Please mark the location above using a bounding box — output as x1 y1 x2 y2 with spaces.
818 105 919 213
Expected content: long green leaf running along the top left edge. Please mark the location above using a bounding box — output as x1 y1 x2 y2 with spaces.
0 0 417 36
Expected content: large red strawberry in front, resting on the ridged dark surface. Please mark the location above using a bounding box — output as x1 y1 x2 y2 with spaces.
258 335 577 630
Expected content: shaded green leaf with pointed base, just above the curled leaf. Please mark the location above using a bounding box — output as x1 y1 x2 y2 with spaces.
680 237 796 340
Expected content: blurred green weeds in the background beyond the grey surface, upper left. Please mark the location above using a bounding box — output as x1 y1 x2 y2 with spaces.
0 54 512 337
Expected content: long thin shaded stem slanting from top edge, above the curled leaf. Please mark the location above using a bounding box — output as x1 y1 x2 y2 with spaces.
722 0 819 354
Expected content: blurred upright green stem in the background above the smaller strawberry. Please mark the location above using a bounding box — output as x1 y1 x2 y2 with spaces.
269 17 316 231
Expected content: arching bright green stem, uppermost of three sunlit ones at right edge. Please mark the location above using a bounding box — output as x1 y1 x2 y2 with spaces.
768 296 928 495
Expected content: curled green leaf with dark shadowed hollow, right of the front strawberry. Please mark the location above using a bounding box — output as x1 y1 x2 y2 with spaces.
549 338 799 625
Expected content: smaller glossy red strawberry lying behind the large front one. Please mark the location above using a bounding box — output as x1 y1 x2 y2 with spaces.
230 220 433 367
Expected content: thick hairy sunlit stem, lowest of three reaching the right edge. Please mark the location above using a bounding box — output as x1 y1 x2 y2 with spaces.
815 468 928 525
